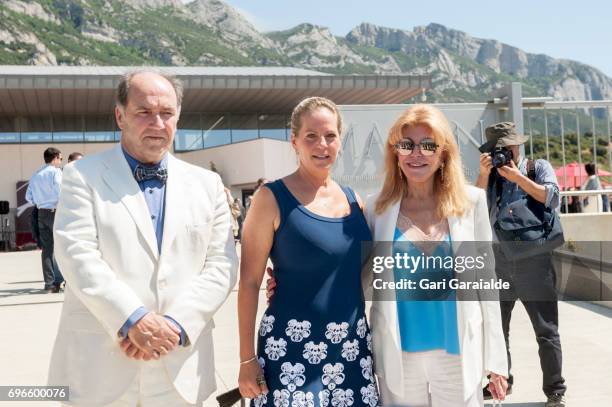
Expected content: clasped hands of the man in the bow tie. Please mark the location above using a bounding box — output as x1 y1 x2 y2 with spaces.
122 312 180 360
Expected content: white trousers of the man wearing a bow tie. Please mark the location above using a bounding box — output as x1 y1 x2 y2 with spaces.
65 360 193 407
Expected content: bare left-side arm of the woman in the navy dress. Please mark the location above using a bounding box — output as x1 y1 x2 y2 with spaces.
238 187 280 398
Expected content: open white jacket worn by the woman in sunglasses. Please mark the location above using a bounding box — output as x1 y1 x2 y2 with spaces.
364 186 508 399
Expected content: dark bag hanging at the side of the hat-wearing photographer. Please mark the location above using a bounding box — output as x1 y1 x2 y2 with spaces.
493 160 565 260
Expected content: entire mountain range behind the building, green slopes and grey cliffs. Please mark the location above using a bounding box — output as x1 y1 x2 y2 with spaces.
0 0 612 101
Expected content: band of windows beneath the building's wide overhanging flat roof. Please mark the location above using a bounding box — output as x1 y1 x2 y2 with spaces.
0 113 290 151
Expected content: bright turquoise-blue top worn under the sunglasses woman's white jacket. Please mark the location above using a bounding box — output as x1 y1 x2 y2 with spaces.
393 227 460 355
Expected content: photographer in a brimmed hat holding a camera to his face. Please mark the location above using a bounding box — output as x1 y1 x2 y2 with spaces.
476 122 566 407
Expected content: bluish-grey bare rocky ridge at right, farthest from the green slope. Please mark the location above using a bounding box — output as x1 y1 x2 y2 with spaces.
346 23 612 100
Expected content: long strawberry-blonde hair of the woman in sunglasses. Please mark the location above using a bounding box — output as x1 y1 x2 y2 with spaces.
375 104 471 219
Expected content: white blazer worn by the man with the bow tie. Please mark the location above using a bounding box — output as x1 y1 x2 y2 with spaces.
49 145 238 405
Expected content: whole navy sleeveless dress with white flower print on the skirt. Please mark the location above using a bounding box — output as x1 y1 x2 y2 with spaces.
252 180 378 407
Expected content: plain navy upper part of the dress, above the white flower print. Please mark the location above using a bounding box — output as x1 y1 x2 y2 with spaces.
266 180 372 314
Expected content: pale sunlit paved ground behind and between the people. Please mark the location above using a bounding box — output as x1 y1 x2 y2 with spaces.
0 252 612 407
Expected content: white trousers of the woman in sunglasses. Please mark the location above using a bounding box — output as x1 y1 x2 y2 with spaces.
379 350 484 407
